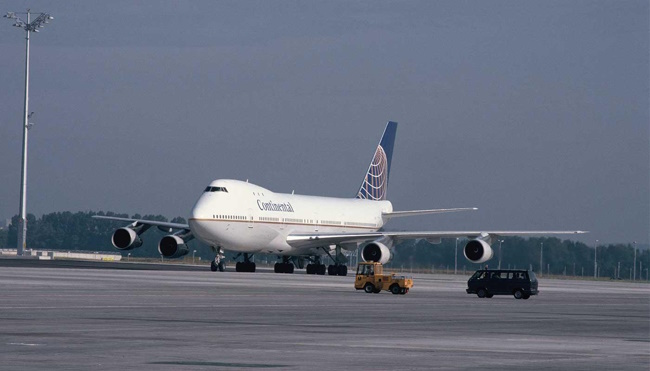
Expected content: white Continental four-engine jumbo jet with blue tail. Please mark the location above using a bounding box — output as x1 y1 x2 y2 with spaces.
94 121 586 276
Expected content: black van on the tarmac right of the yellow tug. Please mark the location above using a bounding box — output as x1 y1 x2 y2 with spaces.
466 269 538 299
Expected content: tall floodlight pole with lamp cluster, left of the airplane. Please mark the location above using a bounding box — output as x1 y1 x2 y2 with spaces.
4 9 54 256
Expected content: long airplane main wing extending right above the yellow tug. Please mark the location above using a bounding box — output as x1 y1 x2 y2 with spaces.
287 231 587 248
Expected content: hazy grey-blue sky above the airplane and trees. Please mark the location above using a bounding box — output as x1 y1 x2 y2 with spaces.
0 0 650 244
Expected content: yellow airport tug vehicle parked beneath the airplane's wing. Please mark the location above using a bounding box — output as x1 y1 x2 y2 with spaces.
354 262 413 295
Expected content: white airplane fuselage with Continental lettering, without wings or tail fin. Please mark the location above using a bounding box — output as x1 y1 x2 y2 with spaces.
189 179 393 255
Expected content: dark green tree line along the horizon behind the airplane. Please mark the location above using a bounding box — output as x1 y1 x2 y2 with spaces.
0 211 650 279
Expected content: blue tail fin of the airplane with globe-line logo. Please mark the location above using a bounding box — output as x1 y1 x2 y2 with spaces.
357 121 397 201
